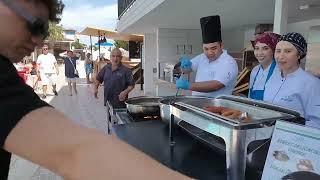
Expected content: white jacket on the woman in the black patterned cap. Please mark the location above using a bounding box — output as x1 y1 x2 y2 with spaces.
264 68 320 128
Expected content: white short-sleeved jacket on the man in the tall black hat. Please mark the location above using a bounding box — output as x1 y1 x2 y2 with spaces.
191 50 238 97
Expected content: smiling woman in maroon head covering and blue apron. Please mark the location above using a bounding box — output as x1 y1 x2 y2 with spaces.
249 32 280 100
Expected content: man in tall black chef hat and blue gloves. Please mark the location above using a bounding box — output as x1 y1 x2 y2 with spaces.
176 16 238 97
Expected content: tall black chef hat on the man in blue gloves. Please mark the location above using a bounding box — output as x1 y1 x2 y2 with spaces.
200 15 222 44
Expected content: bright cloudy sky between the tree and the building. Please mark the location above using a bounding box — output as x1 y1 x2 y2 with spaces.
60 0 118 44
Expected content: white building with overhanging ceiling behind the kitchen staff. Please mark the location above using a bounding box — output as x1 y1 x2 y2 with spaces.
117 0 320 95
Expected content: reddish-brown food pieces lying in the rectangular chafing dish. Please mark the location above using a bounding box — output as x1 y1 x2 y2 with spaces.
203 106 251 122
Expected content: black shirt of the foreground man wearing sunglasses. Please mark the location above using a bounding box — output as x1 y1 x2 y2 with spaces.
0 55 49 180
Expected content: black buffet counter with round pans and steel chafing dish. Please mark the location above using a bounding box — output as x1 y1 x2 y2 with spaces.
107 95 305 180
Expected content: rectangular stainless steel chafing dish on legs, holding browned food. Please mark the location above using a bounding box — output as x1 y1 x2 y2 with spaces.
169 96 302 180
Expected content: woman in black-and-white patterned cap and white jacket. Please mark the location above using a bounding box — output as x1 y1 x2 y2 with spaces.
264 33 320 128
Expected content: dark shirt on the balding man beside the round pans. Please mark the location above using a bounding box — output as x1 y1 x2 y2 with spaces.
97 64 134 108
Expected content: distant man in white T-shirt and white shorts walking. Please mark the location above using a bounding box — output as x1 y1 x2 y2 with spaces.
37 45 59 99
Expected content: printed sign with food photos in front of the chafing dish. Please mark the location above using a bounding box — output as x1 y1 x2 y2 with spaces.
262 121 320 180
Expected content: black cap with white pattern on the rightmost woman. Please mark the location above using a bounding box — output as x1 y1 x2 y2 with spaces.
279 32 307 59
